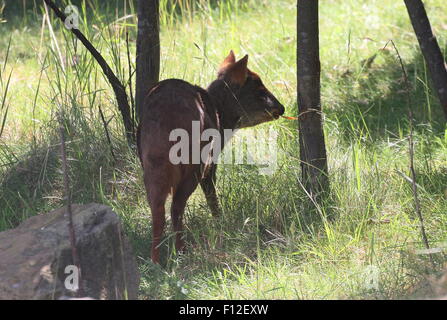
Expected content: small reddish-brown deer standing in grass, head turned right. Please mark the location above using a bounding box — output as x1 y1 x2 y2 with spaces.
137 51 284 263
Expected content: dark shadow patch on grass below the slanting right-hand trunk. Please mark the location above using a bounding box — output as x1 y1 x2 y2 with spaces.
326 46 445 143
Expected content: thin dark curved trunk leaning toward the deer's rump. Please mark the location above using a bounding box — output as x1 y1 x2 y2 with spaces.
44 0 135 144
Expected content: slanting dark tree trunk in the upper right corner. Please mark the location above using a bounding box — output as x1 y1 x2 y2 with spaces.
404 0 447 120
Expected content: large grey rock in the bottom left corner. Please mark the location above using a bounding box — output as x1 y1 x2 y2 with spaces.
0 204 139 299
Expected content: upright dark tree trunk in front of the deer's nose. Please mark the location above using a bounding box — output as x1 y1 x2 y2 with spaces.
297 0 329 199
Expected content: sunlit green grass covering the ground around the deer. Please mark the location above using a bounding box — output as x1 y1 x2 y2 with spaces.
0 0 447 299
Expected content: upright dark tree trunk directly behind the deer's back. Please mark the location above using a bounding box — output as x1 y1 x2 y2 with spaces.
135 0 160 120
